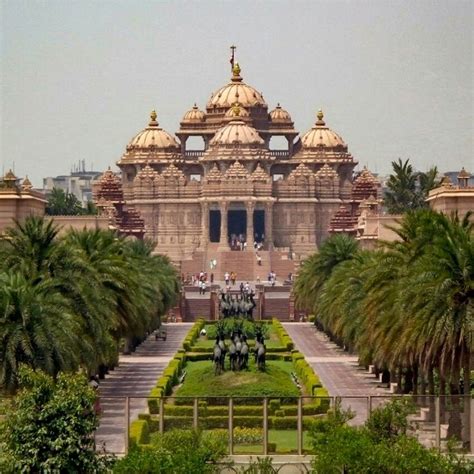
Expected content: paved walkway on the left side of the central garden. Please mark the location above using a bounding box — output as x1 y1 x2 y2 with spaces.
96 323 192 454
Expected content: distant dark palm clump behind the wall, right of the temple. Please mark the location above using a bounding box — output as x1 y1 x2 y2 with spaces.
384 158 439 214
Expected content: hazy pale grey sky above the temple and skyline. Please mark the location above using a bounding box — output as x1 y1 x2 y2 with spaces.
0 0 474 186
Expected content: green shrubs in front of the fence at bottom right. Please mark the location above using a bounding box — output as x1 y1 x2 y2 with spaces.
310 401 474 474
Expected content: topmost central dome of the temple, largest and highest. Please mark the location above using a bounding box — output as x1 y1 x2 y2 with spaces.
206 64 267 108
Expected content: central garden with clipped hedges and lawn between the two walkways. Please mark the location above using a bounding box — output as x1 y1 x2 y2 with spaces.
130 320 330 453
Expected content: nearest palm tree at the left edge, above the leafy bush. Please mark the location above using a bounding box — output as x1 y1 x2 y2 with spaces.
0 270 79 391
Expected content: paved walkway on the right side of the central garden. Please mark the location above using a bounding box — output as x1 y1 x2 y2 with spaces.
283 323 389 424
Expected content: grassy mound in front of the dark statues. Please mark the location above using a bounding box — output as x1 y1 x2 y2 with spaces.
173 358 300 398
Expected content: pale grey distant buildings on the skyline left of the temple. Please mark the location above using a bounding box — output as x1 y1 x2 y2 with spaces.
43 160 102 207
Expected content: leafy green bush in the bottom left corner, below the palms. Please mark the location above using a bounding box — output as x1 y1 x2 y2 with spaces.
1 367 110 473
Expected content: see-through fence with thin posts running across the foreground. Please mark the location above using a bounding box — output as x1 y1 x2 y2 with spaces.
95 395 474 456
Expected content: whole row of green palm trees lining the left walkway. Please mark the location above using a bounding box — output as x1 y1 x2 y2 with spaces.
0 217 179 391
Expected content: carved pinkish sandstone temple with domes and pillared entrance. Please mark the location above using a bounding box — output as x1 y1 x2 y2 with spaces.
95 64 362 261
